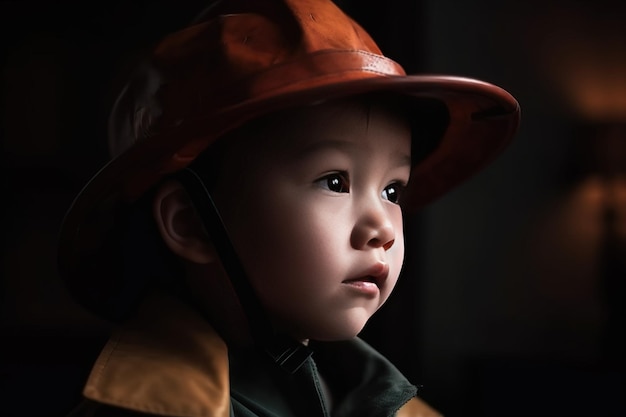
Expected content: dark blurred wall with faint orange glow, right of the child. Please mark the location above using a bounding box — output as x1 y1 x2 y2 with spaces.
420 0 626 416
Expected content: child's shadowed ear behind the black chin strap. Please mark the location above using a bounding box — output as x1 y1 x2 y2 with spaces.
152 181 217 264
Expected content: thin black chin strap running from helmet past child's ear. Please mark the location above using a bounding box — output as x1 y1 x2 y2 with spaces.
173 167 313 373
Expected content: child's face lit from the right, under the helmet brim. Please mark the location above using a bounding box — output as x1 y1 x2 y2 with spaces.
216 101 411 340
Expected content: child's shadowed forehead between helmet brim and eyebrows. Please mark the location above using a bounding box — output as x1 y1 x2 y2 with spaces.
210 97 412 173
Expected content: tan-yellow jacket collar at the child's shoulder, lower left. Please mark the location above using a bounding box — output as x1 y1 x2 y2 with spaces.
83 296 230 417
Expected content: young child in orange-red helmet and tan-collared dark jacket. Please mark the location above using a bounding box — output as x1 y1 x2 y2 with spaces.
59 0 519 417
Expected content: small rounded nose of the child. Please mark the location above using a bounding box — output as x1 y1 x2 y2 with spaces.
351 202 396 251
